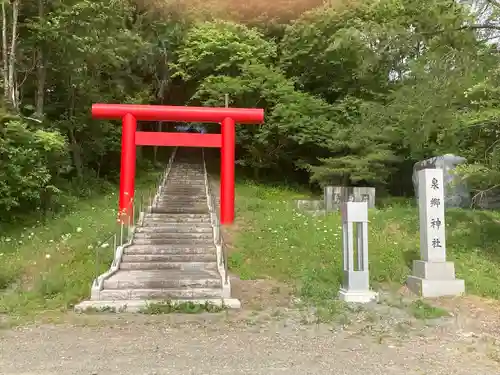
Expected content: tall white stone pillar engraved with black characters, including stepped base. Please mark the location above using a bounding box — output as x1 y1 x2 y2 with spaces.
407 169 465 297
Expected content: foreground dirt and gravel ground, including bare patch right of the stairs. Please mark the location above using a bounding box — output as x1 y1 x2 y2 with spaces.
0 279 500 375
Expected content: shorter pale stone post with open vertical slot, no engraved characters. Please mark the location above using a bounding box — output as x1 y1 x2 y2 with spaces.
339 202 377 303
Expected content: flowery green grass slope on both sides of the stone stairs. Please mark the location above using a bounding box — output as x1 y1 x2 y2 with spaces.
0 174 500 324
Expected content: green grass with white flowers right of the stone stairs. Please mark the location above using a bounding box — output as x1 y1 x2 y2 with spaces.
230 179 500 302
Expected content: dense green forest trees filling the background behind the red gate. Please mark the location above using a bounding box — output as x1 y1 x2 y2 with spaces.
0 0 500 217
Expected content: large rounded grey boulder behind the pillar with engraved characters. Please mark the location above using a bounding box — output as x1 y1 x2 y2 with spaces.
412 154 471 208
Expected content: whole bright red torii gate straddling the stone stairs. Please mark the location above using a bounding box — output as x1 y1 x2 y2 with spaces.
92 104 264 224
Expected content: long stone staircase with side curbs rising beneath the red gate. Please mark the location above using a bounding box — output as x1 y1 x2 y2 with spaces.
75 148 240 311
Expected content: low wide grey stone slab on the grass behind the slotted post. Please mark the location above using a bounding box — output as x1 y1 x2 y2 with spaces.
323 186 375 212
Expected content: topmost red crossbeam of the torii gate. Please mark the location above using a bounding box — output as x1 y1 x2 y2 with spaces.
92 103 264 124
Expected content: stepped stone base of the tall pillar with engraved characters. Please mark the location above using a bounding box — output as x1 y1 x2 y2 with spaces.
406 260 465 298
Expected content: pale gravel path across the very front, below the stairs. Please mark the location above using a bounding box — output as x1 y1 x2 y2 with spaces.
0 317 500 375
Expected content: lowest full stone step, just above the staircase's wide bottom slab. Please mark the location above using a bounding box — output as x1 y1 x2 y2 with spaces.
99 288 222 300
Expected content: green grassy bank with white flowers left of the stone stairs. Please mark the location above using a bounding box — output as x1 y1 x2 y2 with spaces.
0 172 158 320
